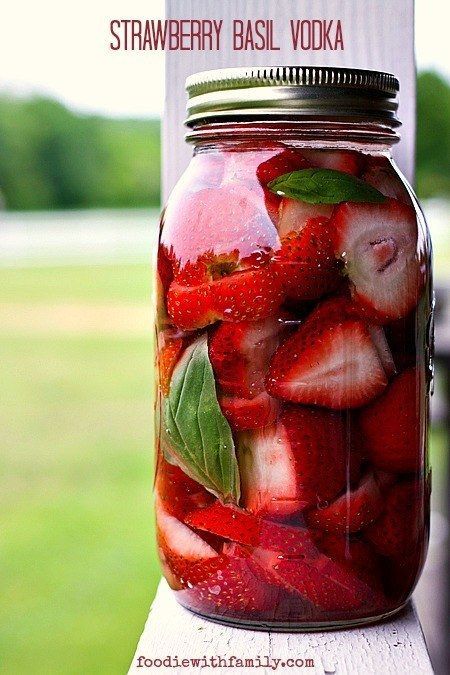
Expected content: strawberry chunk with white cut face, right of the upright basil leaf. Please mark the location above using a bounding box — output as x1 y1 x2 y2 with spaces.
238 406 346 517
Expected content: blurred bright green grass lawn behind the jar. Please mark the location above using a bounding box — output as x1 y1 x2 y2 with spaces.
0 265 444 675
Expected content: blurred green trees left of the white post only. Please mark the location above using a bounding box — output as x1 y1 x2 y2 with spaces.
0 97 160 209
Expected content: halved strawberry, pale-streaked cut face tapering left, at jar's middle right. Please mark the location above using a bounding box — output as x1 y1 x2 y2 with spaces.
266 298 388 409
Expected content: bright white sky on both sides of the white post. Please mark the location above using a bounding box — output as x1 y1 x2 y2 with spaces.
0 0 450 117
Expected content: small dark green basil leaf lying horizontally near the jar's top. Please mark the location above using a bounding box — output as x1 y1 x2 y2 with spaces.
268 169 386 204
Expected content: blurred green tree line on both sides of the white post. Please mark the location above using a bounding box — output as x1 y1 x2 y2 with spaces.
0 72 450 210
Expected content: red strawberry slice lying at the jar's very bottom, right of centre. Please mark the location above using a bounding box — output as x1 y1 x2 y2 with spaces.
254 550 383 613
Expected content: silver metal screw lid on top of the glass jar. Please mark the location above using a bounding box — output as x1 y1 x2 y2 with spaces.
185 66 400 128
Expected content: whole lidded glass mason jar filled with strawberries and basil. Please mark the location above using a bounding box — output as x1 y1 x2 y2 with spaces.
155 67 432 631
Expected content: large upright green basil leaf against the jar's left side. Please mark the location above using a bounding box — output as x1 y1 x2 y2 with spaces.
164 336 240 503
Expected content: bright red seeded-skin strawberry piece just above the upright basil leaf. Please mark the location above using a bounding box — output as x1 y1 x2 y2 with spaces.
167 263 283 330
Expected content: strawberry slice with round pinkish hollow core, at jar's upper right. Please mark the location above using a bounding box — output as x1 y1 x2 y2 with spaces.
331 199 422 321
